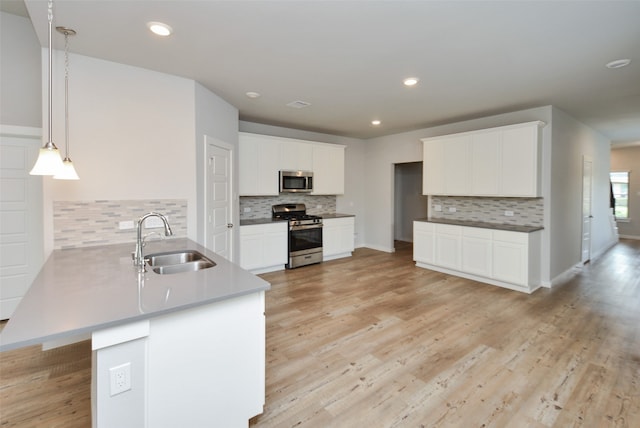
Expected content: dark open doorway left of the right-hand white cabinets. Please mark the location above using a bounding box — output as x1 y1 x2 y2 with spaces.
393 162 429 246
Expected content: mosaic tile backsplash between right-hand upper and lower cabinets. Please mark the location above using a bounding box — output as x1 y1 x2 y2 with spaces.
429 196 544 226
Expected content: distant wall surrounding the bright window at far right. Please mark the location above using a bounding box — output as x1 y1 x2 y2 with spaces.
611 146 640 239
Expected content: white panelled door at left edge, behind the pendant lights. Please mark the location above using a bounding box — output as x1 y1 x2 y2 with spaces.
0 127 44 319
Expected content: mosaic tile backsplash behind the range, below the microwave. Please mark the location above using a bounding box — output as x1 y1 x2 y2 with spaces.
240 193 336 220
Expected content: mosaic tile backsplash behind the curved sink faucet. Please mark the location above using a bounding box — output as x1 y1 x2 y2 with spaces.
53 199 187 249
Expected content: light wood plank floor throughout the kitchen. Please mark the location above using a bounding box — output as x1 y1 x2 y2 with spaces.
0 241 640 428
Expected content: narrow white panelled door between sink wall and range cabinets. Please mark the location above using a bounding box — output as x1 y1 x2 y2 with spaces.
205 136 233 260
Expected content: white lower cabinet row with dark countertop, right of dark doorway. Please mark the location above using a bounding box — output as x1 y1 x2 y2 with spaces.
413 221 541 293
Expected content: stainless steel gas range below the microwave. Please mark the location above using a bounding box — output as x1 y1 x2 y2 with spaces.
271 204 322 269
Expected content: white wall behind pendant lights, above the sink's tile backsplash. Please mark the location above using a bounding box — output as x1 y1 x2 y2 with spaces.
42 49 196 254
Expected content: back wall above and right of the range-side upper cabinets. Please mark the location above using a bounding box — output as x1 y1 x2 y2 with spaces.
240 121 367 247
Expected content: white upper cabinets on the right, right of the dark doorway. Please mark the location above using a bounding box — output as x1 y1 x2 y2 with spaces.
422 121 544 197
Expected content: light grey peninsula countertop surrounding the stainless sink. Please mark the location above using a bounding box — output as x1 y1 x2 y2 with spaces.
0 239 270 351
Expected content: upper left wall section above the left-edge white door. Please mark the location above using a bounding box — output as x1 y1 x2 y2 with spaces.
0 12 40 128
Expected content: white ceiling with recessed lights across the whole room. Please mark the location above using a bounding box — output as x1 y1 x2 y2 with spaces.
8 0 640 143
